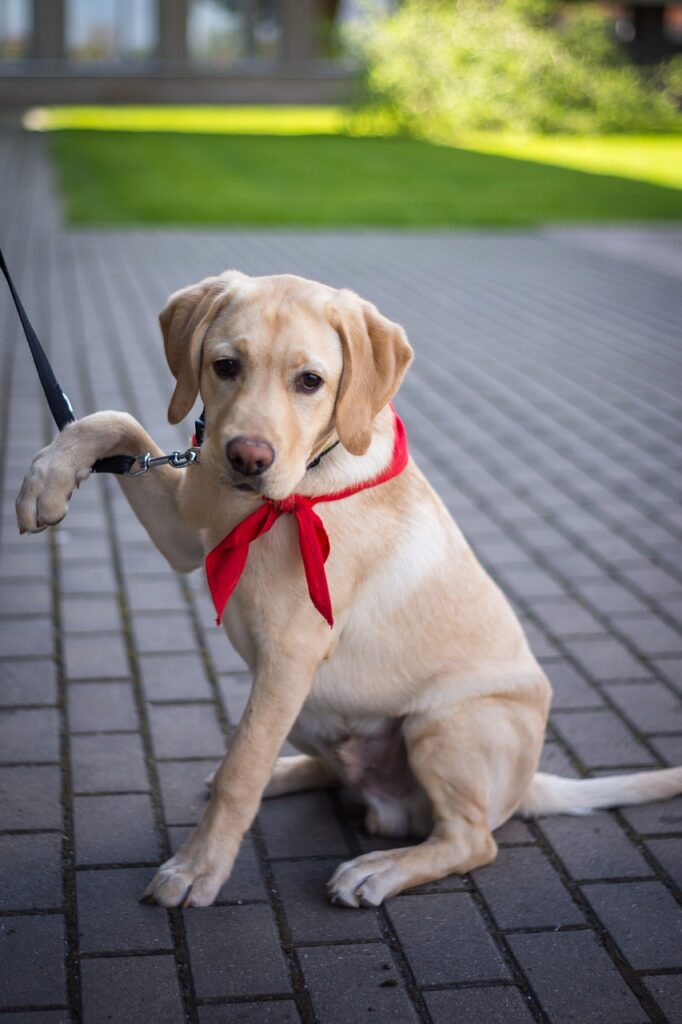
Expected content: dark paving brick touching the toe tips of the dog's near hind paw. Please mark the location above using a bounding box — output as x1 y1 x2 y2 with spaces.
273 860 381 943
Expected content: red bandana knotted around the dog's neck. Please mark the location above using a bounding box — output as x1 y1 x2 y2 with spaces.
206 413 409 626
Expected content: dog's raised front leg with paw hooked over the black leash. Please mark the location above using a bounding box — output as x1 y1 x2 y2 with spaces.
16 412 203 572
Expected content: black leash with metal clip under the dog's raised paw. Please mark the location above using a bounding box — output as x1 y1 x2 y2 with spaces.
0 249 200 476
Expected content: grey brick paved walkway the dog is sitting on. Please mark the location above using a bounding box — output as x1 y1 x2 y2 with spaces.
0 128 682 1024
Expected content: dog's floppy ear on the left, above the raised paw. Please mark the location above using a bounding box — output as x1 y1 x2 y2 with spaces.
159 270 246 423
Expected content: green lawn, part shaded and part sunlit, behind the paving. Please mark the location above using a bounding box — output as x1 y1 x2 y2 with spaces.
34 108 682 227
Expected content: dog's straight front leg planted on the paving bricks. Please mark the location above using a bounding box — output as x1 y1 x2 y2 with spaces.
144 643 321 906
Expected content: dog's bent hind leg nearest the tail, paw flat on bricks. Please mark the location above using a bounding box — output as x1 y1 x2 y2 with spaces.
328 681 549 906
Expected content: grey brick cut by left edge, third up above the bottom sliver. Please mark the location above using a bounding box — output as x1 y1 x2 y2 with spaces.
0 765 61 828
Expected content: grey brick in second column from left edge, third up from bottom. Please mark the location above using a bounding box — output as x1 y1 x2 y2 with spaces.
74 793 159 864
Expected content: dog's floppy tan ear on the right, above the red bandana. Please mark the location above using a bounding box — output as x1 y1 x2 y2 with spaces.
327 291 414 455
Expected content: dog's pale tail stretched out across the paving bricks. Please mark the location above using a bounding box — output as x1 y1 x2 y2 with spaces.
517 768 682 817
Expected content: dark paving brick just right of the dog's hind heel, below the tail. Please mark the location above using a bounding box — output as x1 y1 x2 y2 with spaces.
473 847 585 928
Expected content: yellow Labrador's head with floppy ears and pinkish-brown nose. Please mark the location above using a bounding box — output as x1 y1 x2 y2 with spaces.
160 270 413 499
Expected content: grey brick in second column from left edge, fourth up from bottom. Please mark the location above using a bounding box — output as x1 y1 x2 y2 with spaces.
71 732 150 793
